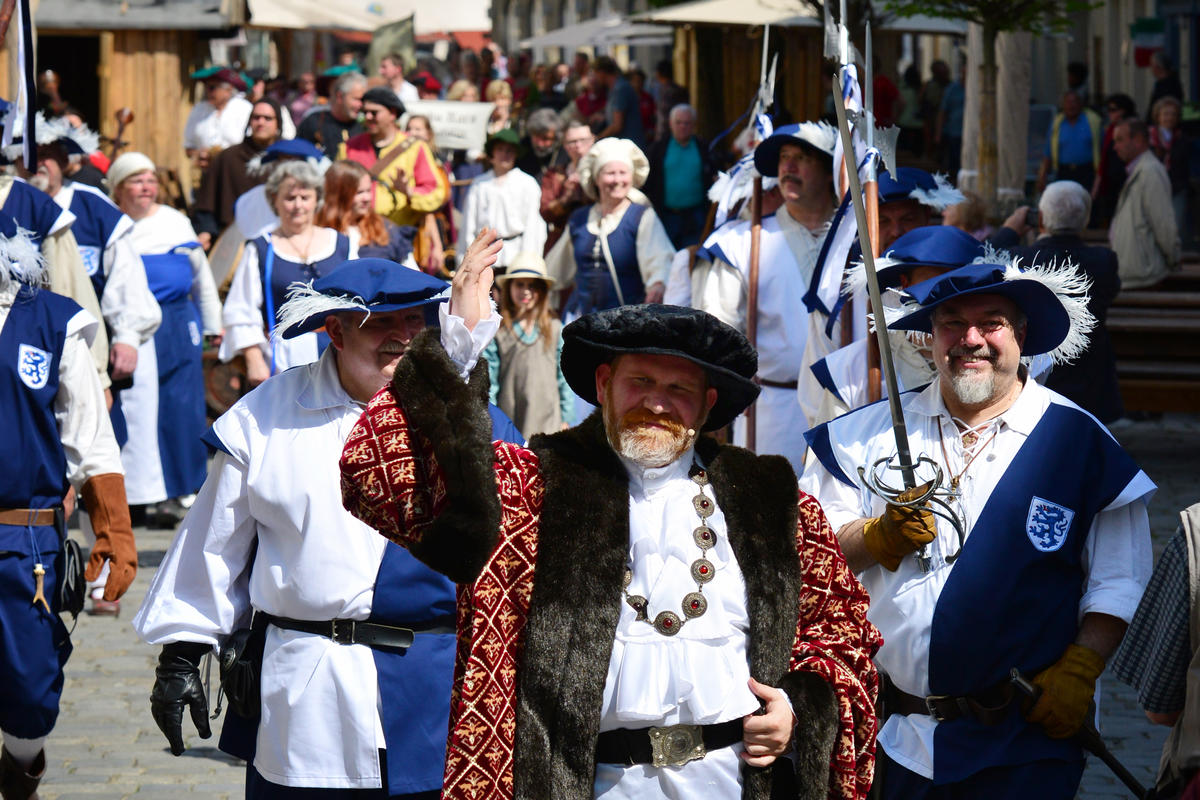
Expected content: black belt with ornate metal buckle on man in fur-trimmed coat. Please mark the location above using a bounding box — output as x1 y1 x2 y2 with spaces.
596 718 743 766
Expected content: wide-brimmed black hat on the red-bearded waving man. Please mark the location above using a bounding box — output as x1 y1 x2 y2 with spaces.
563 305 758 431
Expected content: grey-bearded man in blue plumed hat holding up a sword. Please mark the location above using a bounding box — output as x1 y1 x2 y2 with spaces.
800 259 1154 800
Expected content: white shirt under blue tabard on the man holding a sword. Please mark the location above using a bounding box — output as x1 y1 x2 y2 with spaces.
800 379 1154 778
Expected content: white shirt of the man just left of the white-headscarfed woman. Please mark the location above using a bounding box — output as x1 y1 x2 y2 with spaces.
54 181 162 348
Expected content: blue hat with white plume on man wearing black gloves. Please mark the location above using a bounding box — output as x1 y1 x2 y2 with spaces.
275 258 450 339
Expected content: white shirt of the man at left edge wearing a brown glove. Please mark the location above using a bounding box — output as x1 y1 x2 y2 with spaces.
0 282 125 491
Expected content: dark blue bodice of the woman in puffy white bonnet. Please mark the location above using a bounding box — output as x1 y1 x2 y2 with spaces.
566 203 646 315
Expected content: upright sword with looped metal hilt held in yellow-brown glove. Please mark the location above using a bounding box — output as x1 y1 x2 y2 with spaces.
833 67 966 572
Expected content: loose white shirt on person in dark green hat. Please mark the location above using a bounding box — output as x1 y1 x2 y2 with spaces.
458 169 546 266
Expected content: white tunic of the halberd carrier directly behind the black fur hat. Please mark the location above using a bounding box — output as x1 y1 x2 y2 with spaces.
691 206 828 473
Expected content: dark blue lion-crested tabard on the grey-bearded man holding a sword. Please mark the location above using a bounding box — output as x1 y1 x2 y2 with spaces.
929 403 1139 784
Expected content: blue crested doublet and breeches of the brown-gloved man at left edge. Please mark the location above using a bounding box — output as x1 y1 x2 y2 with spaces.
0 287 79 739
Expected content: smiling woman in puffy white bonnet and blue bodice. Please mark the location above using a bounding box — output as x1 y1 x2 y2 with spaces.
546 139 674 321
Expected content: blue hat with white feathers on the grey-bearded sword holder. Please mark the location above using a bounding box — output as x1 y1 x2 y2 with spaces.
888 259 1096 363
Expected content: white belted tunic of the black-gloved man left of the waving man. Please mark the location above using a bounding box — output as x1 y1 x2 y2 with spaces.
133 312 499 789
